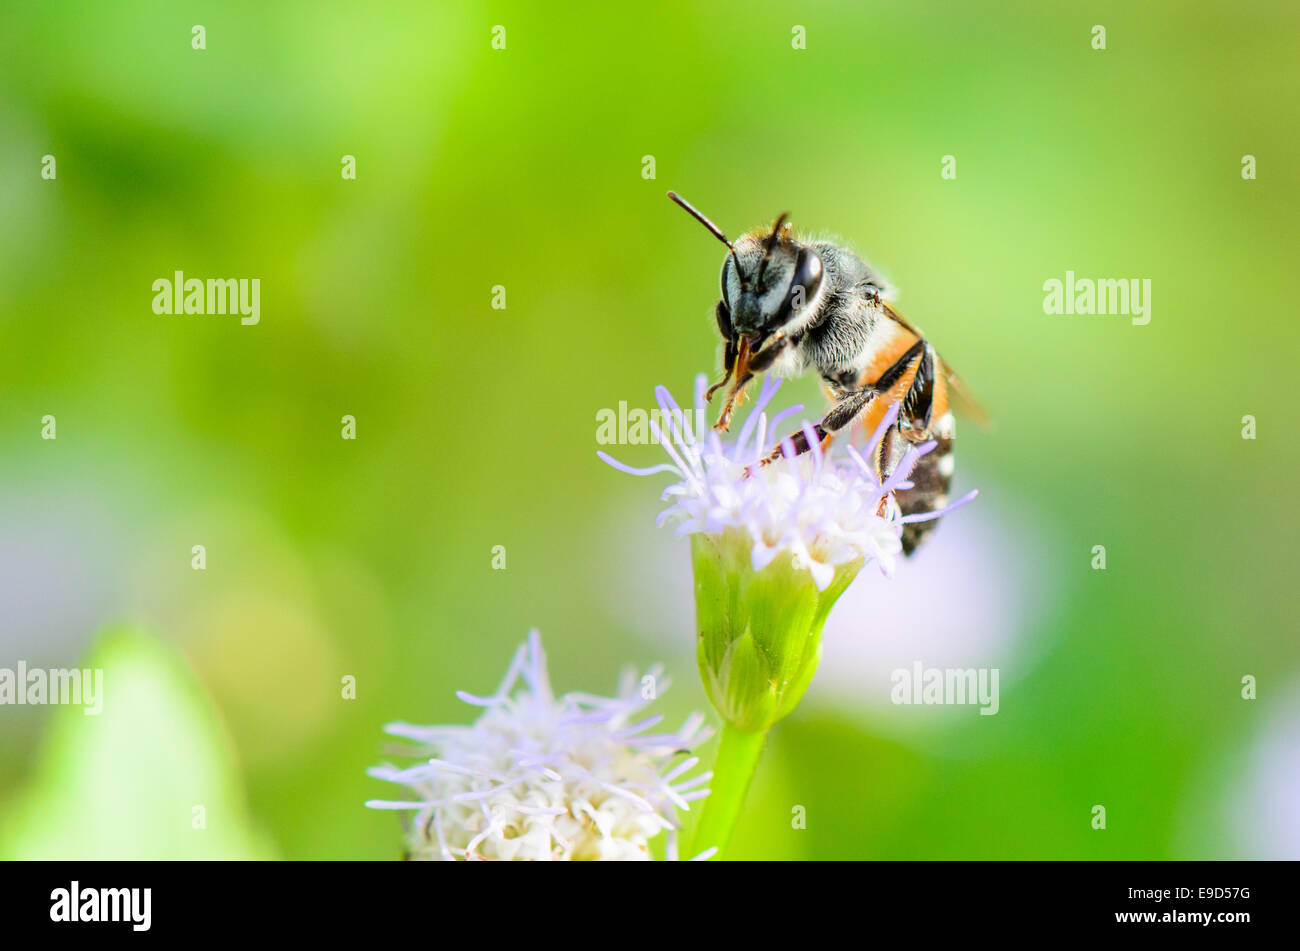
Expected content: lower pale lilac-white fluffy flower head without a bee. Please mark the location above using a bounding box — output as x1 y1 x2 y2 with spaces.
367 630 712 861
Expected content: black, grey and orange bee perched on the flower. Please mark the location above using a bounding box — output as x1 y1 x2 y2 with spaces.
668 191 988 555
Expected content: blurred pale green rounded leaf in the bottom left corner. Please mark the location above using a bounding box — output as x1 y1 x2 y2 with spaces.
0 630 272 859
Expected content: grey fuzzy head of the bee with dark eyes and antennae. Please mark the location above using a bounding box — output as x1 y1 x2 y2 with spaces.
668 191 823 342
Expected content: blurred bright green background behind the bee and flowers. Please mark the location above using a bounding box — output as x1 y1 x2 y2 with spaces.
0 1 1300 859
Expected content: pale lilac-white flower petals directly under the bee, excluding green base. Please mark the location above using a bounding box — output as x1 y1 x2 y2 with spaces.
598 375 975 590
